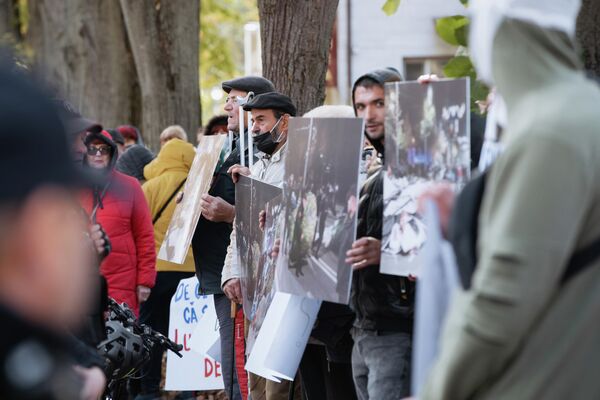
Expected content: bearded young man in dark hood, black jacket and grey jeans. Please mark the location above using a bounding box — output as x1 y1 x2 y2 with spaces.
346 68 414 400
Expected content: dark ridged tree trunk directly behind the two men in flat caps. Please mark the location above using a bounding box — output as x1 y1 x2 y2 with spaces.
258 0 338 115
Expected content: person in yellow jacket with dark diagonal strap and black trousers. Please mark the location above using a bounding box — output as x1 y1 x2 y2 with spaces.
140 137 196 398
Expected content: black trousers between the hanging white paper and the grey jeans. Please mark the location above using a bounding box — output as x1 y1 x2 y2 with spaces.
300 344 356 400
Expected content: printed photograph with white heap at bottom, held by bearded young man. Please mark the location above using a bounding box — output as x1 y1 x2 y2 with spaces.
380 79 471 276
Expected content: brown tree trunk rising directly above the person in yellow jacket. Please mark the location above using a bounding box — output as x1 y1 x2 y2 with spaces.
121 0 200 149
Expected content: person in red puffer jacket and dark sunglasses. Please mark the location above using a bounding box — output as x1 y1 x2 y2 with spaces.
82 131 156 315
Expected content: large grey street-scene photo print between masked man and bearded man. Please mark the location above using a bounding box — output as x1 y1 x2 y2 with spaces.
276 118 363 304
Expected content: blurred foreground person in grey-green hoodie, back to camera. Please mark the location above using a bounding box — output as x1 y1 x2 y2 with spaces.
421 0 600 399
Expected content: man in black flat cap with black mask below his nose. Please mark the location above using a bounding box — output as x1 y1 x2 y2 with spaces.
221 92 298 400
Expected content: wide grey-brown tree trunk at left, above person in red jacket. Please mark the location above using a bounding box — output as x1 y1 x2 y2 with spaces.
27 0 140 134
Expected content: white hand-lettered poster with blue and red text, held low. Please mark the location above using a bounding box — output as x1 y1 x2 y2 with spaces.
165 277 223 391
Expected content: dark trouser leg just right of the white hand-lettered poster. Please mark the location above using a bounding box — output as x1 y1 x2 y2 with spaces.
214 294 242 400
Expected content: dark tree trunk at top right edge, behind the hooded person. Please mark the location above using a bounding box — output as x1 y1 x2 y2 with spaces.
577 0 600 76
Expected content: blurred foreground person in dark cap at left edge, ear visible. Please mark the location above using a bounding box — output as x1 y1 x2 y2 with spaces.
0 60 98 400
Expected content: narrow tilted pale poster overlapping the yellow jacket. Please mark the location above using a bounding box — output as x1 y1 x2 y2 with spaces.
158 135 227 264
